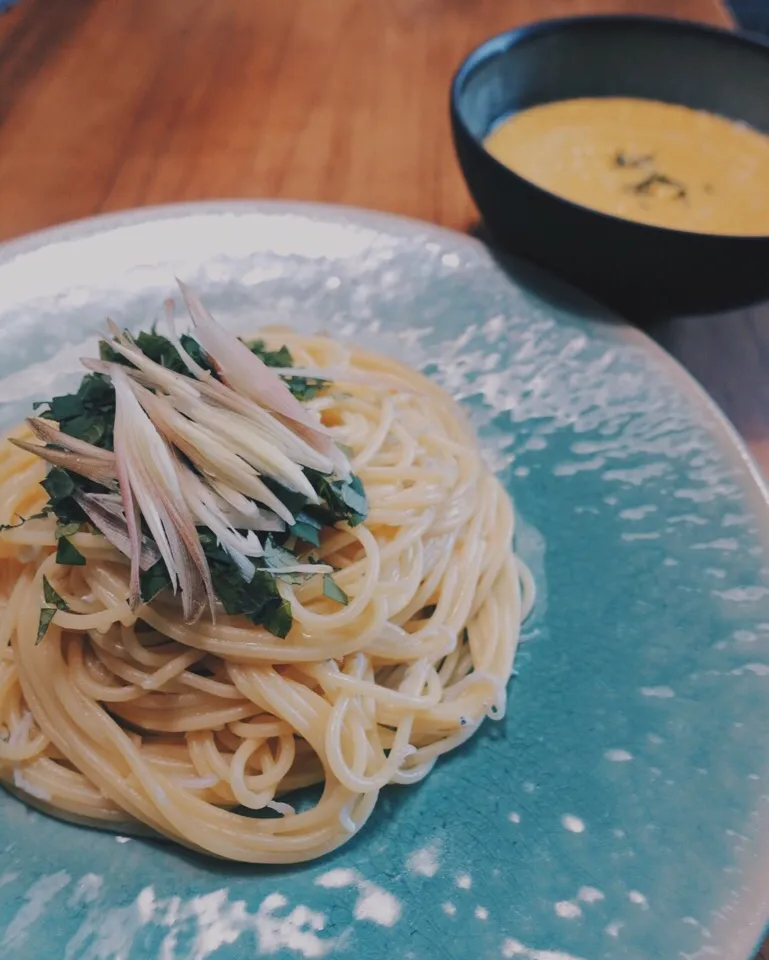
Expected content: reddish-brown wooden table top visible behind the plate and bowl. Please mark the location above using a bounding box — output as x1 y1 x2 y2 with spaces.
0 0 769 960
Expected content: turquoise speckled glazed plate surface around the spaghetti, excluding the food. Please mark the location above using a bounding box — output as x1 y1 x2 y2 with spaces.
0 203 769 960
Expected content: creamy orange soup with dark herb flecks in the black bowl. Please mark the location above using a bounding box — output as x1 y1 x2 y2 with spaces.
484 97 769 235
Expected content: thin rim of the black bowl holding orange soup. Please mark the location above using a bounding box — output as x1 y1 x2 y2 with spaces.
449 13 769 245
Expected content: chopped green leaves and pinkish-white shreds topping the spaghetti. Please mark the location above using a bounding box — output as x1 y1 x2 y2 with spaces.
12 285 360 637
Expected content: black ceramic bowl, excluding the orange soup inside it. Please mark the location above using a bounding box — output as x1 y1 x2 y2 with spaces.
451 16 769 322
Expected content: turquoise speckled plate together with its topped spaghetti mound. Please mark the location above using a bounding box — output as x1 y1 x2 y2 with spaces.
0 202 769 960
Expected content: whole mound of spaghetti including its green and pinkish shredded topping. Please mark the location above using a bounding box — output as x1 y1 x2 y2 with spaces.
0 287 533 863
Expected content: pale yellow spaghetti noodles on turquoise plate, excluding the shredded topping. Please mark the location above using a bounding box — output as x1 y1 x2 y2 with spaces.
0 318 533 863
